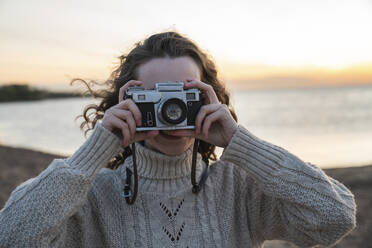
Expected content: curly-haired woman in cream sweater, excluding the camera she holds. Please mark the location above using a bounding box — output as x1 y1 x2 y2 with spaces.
0 32 355 247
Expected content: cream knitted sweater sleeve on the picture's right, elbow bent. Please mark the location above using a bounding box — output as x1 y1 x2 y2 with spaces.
221 126 356 247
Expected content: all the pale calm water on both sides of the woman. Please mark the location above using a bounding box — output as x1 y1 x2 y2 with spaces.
0 86 372 168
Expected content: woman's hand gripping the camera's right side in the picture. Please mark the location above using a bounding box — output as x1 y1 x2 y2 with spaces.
172 80 238 148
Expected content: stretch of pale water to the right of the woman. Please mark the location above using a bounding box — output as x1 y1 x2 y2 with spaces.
234 84 372 168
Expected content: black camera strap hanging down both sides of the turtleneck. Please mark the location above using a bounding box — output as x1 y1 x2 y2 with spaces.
123 139 209 205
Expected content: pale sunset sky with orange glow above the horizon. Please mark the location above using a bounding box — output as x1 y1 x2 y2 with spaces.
0 0 372 88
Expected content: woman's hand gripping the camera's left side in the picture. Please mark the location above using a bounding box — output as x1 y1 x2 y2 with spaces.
102 80 159 147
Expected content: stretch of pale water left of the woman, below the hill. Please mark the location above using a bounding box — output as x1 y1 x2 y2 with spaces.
0 98 93 155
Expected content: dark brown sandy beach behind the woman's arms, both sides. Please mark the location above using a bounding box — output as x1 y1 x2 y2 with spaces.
0 145 372 248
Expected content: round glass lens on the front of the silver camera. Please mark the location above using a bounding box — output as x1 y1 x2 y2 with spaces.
161 98 187 124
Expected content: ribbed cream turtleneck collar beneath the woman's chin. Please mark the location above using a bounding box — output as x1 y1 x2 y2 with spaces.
125 143 204 180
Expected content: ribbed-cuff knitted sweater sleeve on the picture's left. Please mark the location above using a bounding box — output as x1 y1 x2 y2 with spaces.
0 123 122 247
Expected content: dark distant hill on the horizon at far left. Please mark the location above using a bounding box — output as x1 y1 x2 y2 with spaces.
0 84 82 102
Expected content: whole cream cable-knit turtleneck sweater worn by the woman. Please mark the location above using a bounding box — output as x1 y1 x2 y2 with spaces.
0 124 355 248
